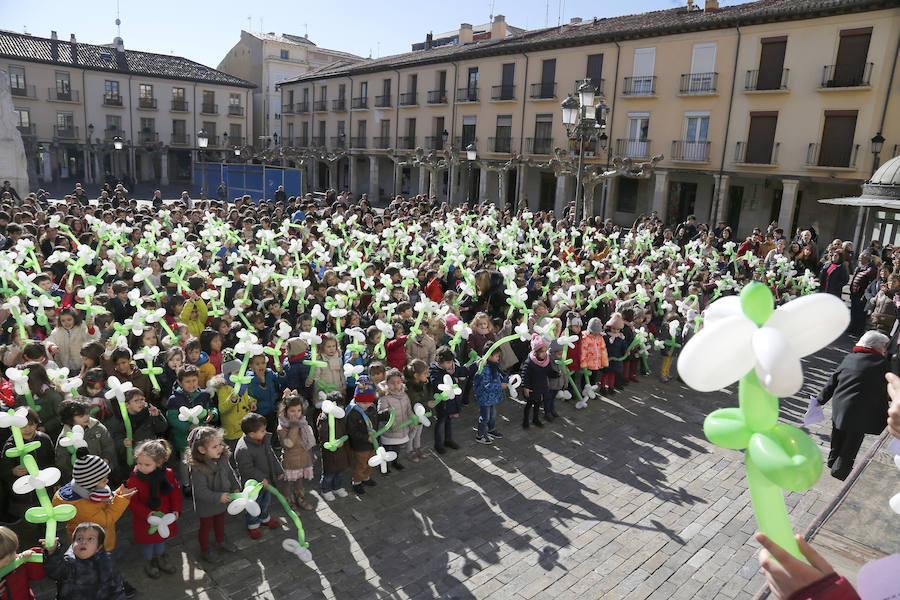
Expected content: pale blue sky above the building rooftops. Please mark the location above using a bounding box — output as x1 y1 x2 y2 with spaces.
0 0 740 67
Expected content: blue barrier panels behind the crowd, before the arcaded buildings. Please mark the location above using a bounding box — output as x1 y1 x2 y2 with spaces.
192 162 303 202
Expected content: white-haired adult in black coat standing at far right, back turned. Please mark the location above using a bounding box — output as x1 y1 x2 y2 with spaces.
819 331 890 480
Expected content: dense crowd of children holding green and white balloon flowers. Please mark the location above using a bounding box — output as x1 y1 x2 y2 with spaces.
0 190 824 598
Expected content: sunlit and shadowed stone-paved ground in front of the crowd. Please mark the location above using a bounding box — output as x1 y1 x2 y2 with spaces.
28 338 870 600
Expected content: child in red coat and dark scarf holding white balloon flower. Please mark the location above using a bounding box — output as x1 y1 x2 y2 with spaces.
127 439 181 579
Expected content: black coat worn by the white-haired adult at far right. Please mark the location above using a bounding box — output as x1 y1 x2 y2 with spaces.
819 352 890 434
